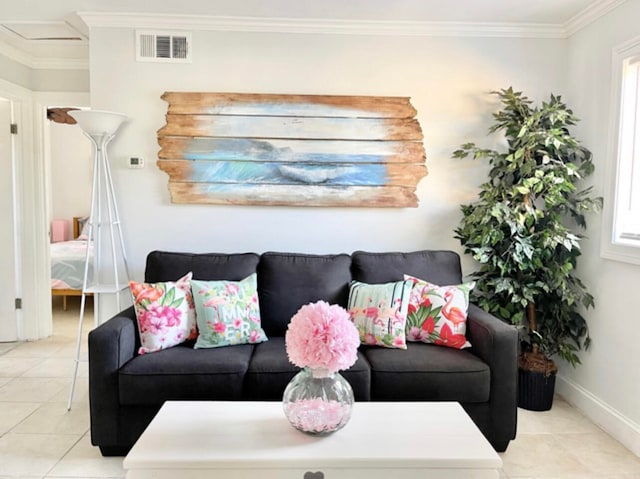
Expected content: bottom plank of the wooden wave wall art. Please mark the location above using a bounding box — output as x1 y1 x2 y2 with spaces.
169 182 418 208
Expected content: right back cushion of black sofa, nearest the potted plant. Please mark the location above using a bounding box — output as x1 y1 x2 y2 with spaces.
351 250 462 286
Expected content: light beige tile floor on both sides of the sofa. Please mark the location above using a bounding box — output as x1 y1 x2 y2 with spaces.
0 298 640 479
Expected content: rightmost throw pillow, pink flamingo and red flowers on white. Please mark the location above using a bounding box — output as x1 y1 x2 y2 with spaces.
404 274 475 349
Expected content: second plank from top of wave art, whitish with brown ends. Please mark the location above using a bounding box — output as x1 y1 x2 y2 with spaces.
158 114 422 141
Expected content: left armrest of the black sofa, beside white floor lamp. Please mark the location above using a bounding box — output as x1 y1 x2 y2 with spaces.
89 307 137 445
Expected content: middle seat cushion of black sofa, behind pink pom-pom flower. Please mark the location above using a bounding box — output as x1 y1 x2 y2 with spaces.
244 337 371 401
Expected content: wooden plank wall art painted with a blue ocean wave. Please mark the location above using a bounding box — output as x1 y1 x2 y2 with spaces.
158 92 427 207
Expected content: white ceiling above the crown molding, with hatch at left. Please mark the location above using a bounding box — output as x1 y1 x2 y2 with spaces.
0 0 627 68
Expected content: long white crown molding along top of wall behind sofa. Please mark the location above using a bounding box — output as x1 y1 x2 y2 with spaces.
78 12 565 38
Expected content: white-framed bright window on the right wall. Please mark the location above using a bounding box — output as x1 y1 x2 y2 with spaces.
601 37 640 264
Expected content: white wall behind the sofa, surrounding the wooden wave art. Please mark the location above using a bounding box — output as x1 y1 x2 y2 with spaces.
90 28 566 284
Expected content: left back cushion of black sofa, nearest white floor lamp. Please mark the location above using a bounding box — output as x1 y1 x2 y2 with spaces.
145 251 260 283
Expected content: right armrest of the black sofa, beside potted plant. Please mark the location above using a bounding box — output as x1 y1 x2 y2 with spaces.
467 304 518 447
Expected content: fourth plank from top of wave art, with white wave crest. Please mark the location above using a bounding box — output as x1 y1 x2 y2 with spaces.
158 160 427 188
